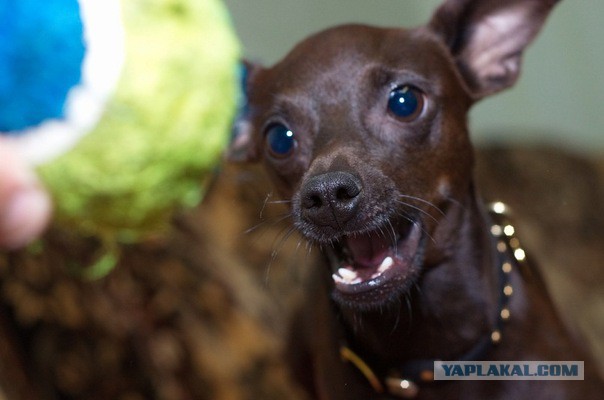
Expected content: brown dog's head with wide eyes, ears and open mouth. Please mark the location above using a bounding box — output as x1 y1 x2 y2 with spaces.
229 0 556 307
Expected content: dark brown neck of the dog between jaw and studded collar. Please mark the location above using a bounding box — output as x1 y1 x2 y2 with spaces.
338 189 499 365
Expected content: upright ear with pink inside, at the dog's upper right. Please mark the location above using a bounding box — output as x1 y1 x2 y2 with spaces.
429 0 558 99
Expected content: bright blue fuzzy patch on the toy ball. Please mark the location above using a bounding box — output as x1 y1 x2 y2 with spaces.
0 0 85 134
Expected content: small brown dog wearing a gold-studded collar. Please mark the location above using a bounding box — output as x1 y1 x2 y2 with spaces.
230 0 602 400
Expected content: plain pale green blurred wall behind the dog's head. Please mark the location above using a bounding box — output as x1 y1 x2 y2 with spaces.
225 0 604 154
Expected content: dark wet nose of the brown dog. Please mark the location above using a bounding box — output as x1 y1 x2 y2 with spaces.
300 171 362 230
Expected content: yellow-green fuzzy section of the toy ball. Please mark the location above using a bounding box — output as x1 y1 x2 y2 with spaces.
39 0 239 243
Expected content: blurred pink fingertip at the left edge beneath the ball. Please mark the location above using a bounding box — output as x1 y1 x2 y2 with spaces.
0 187 51 249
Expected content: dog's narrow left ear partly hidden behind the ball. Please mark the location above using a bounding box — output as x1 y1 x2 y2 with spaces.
226 60 261 162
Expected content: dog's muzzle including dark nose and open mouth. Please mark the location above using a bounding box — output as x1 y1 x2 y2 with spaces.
294 171 425 306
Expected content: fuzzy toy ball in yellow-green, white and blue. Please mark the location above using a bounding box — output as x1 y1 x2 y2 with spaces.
0 0 239 260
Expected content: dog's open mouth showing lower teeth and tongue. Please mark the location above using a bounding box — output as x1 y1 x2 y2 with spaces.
327 222 423 303
